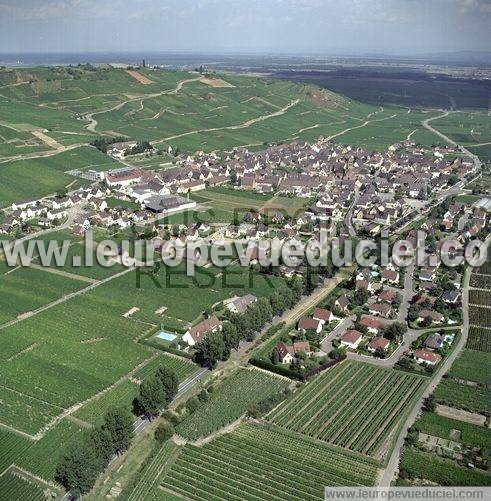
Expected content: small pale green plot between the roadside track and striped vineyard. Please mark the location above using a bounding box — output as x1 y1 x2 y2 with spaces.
176 369 287 440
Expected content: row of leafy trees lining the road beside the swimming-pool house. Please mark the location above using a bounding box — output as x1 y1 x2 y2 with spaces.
194 277 304 368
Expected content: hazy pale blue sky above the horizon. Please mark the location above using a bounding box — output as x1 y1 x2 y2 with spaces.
0 0 491 54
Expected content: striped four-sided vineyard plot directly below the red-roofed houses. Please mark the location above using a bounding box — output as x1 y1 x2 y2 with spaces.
268 362 423 456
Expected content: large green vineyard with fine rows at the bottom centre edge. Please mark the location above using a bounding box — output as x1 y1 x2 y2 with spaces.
161 424 377 500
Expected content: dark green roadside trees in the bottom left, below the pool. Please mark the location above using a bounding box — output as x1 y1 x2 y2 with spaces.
55 366 179 497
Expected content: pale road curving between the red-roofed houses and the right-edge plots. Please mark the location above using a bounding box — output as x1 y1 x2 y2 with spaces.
380 268 471 487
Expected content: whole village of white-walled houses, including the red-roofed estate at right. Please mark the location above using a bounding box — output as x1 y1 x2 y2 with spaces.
0 138 489 372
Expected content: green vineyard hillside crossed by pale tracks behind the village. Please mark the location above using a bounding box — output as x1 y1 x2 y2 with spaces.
0 66 430 208
